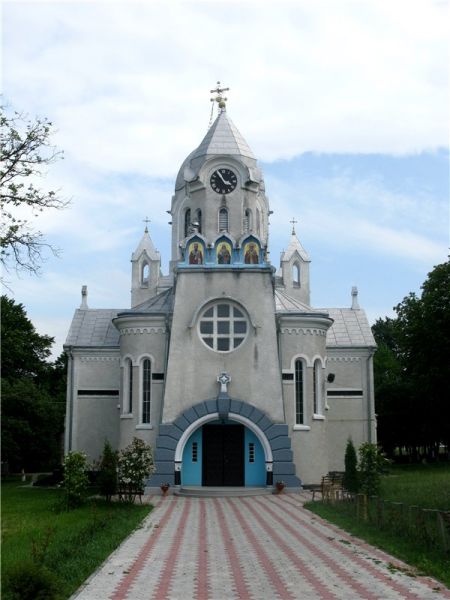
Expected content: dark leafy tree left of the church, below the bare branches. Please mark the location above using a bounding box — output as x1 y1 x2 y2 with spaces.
1 296 66 471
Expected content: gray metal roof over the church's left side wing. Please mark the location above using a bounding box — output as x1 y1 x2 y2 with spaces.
66 308 120 346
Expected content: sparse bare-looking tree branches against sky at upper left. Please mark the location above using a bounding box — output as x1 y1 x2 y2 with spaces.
0 106 68 274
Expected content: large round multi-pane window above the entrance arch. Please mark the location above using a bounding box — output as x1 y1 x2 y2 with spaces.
198 302 248 352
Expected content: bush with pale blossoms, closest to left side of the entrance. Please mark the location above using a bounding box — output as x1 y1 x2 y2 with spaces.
118 438 155 502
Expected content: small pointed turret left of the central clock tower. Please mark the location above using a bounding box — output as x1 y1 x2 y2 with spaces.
131 219 161 308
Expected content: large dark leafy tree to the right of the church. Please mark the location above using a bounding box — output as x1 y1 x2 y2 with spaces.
372 261 450 460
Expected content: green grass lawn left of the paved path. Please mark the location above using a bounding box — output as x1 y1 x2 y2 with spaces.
2 480 151 598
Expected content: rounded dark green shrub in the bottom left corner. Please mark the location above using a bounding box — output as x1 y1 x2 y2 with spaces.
2 560 60 600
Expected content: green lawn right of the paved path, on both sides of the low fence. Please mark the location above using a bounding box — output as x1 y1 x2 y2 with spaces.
305 463 450 587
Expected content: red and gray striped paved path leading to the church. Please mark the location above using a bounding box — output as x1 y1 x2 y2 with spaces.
75 494 450 600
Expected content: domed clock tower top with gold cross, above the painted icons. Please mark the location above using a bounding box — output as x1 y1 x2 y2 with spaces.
171 83 269 269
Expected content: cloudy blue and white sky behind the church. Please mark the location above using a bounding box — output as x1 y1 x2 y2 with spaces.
1 0 450 357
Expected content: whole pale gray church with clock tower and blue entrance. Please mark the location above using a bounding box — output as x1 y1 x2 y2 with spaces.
65 88 376 488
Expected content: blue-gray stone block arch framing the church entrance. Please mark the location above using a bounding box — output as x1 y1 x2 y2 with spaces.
147 396 301 488
